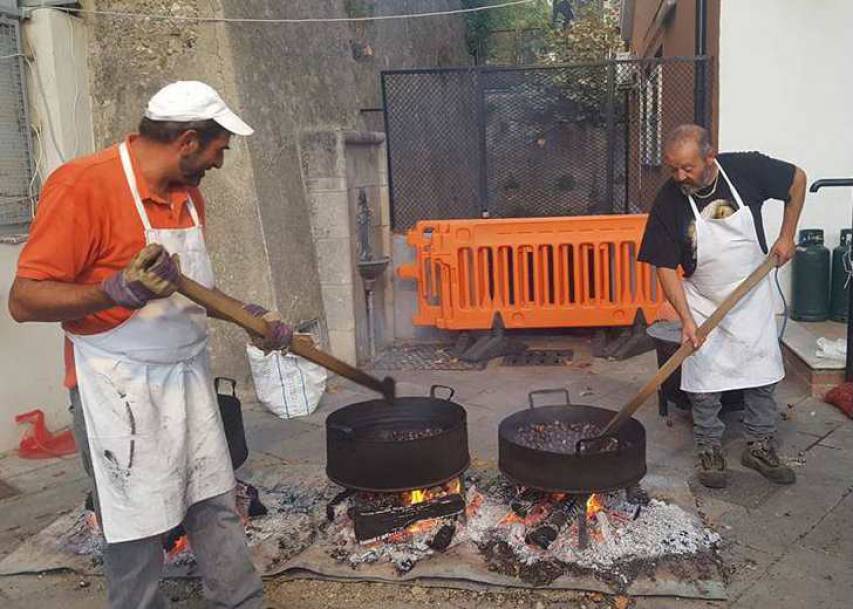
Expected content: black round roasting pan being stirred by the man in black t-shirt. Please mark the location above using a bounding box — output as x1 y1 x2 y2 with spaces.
498 389 646 494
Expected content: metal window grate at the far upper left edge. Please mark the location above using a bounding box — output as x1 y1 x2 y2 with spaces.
0 16 36 227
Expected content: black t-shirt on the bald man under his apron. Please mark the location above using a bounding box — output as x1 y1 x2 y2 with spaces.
638 152 795 277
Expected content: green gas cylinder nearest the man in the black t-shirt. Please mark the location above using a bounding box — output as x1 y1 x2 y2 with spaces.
791 228 829 321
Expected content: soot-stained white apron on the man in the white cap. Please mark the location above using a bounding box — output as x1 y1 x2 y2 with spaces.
69 144 235 543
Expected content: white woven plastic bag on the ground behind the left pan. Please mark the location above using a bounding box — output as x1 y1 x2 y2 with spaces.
246 344 326 419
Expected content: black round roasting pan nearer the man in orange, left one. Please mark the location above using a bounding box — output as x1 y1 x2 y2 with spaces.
326 385 471 492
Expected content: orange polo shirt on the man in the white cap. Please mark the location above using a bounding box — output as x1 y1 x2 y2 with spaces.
17 135 204 388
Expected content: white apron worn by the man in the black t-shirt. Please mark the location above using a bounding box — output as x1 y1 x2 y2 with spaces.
681 163 785 393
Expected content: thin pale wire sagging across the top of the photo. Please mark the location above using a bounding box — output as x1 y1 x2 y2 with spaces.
46 0 536 23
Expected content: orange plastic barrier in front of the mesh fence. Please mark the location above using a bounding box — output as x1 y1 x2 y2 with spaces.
397 214 664 330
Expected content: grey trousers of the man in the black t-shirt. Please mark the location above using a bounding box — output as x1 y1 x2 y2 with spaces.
687 383 777 450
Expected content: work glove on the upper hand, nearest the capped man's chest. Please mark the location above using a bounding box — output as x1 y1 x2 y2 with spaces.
101 243 181 309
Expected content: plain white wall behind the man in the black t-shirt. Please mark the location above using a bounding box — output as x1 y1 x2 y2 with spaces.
719 0 853 304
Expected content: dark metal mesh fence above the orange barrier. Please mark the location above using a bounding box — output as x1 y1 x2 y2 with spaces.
382 57 711 230
